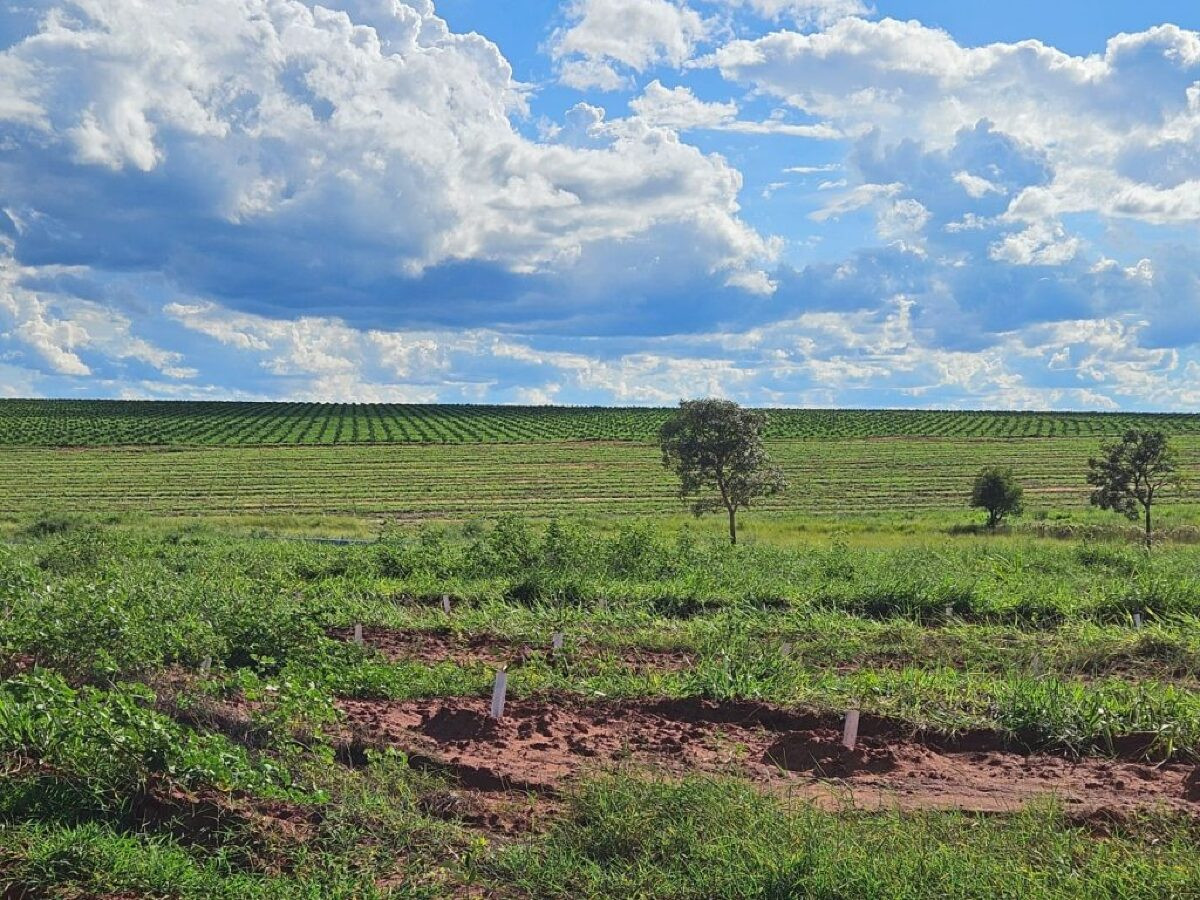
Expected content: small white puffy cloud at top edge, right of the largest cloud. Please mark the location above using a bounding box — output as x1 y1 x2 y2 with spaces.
550 0 715 91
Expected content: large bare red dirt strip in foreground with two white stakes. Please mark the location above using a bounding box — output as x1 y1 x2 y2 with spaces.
340 697 1200 817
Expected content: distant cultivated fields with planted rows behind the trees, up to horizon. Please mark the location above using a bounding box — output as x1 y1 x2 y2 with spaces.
0 401 1200 520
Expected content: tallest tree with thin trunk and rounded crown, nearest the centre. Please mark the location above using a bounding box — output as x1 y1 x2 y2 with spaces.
659 400 787 544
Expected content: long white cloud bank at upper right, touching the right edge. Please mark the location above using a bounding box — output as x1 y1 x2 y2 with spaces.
713 18 1200 230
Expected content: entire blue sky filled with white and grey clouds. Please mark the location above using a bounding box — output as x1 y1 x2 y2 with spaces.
0 0 1200 412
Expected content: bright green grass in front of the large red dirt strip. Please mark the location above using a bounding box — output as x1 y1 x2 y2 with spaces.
490 779 1200 900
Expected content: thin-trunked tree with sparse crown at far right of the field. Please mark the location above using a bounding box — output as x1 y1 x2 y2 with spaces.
1087 431 1178 550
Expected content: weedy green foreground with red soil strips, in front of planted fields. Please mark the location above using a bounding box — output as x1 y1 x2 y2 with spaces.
0 520 1200 900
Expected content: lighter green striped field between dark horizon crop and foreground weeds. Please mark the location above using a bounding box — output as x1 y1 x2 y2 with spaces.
0 438 1200 517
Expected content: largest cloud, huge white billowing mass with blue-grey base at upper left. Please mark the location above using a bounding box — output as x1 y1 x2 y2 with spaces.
0 0 772 333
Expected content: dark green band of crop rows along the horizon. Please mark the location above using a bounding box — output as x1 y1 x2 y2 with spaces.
0 400 1200 446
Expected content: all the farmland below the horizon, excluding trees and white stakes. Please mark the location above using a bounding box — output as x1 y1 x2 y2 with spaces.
0 401 1200 900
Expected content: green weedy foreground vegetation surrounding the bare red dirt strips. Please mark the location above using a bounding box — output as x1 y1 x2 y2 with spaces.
0 513 1200 900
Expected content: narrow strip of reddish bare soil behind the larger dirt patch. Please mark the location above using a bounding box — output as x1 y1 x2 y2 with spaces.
330 625 696 672
